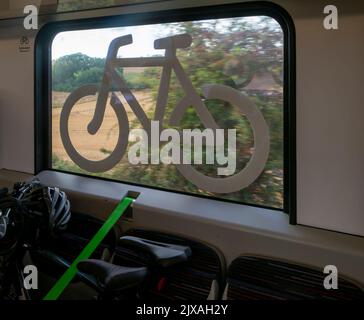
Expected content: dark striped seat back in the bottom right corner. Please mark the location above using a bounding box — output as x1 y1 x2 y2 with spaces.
227 256 364 300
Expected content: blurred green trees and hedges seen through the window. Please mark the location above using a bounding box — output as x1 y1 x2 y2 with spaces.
53 17 283 208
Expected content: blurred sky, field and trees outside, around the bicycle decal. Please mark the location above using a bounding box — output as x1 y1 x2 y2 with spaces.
52 16 284 209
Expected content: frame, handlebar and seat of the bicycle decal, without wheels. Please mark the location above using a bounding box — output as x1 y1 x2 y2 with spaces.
88 35 219 134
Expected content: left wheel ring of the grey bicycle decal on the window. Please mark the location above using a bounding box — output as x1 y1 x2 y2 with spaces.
60 85 129 173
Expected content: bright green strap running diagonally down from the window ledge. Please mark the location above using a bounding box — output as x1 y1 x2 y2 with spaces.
43 197 134 300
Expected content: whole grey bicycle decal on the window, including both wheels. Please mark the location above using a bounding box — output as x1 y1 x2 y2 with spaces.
60 34 270 193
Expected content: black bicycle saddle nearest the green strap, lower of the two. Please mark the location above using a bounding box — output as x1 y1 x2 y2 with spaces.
77 259 147 291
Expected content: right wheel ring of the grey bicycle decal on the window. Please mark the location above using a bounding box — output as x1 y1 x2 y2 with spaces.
172 85 270 193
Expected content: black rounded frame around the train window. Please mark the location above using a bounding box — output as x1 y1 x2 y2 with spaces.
34 1 297 224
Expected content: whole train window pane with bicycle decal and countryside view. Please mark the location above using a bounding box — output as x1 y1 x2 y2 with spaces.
34 5 291 210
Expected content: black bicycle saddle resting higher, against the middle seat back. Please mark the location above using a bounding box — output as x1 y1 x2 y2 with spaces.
120 236 192 268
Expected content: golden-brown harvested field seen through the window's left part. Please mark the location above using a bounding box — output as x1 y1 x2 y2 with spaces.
52 90 155 160
